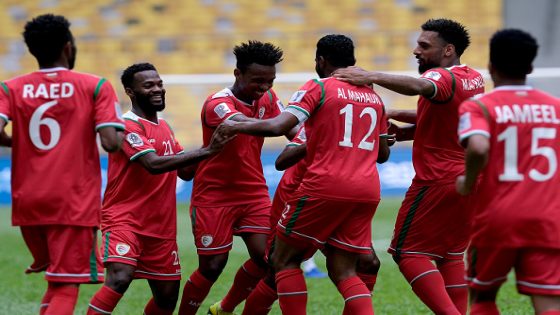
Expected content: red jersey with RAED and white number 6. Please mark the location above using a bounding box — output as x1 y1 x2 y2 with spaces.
0 68 124 226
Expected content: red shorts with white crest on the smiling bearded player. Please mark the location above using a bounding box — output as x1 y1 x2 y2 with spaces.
102 231 181 280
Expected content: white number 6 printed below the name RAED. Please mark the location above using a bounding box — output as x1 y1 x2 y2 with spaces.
29 101 60 150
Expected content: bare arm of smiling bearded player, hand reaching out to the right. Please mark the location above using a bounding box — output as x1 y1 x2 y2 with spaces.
137 126 235 175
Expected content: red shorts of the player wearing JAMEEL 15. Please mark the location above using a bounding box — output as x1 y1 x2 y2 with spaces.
467 246 560 296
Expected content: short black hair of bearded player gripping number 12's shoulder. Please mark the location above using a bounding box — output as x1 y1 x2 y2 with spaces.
422 19 471 57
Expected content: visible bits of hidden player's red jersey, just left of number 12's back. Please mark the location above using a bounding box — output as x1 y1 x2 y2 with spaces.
275 126 307 201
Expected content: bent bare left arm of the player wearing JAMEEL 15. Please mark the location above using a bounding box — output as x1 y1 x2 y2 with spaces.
456 135 490 195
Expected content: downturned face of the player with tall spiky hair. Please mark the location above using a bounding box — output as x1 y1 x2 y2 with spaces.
234 63 276 101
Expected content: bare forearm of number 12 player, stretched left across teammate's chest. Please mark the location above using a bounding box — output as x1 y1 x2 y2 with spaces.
223 112 299 137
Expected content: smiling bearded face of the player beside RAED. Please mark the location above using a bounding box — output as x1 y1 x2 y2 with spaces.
126 70 165 113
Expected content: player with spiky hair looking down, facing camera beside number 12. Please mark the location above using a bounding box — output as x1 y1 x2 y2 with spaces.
179 41 286 315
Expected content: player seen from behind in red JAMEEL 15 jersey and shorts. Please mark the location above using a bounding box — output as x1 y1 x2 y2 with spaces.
457 29 560 315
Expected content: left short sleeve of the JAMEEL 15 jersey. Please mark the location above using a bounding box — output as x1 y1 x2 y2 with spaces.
458 99 490 142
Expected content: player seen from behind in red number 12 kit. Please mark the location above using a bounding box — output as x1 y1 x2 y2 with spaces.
222 35 389 315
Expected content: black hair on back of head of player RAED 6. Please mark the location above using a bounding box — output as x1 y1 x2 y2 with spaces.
23 13 74 65
